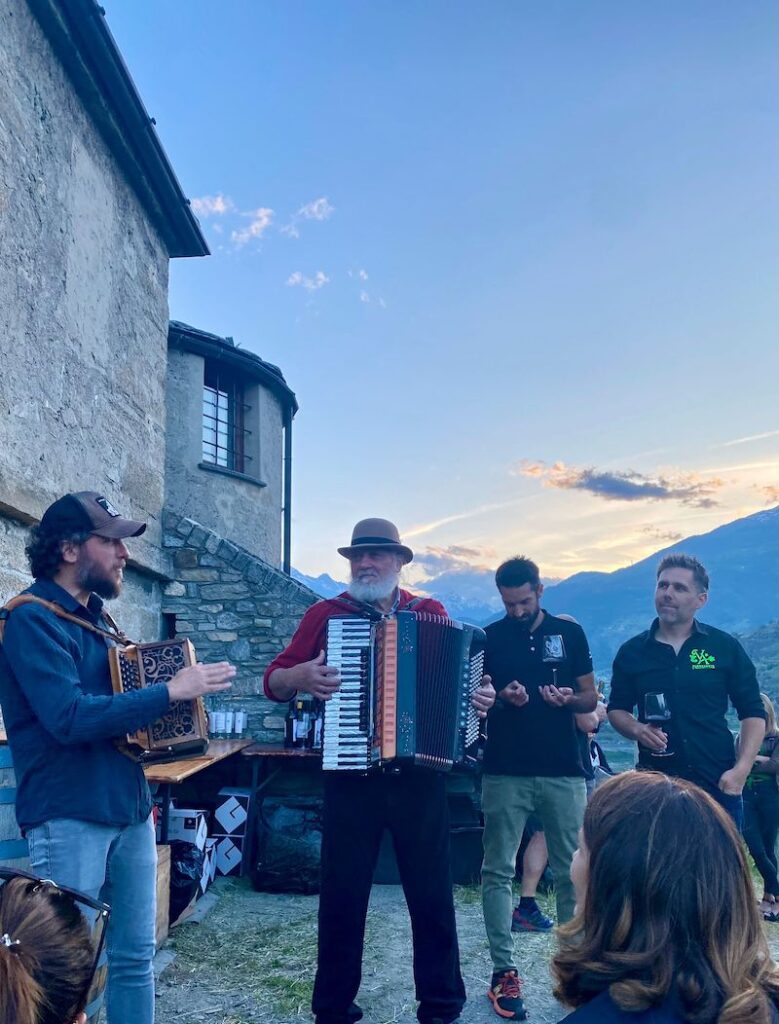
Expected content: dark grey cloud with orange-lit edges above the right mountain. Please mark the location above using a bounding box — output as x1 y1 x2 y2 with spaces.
512 459 723 509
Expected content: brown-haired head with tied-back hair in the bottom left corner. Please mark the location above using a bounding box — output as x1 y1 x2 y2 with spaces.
0 878 94 1024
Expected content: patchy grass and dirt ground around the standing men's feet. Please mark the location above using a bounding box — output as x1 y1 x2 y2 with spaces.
157 882 564 1024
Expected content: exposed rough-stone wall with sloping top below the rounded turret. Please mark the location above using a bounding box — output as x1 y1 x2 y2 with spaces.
163 510 318 742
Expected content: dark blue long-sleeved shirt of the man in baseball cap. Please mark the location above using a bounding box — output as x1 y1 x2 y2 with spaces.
0 580 169 831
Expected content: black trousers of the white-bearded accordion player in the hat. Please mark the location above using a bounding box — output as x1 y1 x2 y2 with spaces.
311 769 465 1024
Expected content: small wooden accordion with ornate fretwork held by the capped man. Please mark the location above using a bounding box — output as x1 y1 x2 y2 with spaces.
109 640 208 764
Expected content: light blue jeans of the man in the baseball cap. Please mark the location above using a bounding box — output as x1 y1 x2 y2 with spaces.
27 816 157 1024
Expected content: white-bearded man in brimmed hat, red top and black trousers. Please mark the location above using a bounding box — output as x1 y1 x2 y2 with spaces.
265 519 494 1024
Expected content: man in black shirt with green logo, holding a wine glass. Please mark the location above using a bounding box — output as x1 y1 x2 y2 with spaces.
609 554 766 827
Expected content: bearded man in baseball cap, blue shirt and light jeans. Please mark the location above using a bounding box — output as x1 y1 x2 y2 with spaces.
0 490 235 1024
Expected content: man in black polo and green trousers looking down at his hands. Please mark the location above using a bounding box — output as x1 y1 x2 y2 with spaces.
482 558 598 1020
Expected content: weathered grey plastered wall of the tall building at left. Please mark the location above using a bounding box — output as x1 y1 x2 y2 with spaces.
0 0 168 571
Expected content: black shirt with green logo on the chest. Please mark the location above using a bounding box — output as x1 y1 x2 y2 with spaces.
609 618 766 785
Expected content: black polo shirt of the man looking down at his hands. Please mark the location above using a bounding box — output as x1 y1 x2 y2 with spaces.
484 611 593 778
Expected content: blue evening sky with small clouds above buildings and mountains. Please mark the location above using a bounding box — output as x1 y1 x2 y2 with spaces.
105 0 779 577
